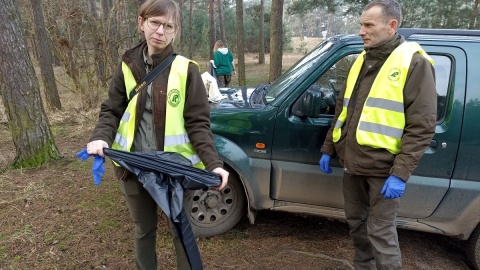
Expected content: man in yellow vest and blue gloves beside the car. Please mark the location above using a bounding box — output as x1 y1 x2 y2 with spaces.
320 0 437 269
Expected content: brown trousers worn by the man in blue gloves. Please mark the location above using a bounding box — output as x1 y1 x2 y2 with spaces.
343 173 402 270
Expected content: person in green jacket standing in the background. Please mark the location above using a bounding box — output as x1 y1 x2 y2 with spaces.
213 40 237 87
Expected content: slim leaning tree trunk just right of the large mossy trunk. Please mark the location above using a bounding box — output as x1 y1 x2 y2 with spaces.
30 0 62 111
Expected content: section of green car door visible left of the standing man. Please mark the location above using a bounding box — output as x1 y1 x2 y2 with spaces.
271 46 362 208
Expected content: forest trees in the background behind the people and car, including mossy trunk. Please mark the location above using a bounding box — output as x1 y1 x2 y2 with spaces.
0 0 479 168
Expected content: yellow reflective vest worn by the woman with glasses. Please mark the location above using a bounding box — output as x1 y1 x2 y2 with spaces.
112 55 205 169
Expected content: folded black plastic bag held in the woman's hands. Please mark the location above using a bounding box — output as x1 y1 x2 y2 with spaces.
103 148 221 270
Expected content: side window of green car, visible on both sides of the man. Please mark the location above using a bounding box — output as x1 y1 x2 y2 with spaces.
310 54 452 123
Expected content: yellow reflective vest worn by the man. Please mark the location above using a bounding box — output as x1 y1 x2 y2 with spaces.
333 42 433 154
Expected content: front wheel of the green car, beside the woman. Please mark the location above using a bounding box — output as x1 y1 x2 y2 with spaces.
183 172 246 237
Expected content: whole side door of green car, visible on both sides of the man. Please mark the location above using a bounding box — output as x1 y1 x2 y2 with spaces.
271 42 465 218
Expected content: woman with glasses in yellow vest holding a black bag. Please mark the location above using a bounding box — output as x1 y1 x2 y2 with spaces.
87 0 228 269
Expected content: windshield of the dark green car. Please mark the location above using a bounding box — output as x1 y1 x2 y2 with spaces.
265 40 333 103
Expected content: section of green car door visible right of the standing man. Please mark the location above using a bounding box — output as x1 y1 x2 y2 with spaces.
398 43 467 218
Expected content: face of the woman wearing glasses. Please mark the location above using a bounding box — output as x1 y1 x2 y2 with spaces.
138 16 178 55
